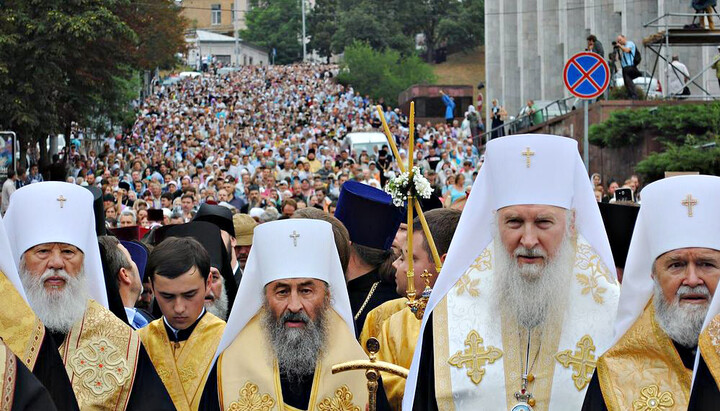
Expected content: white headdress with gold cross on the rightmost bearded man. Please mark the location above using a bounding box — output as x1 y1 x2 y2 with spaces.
613 175 720 344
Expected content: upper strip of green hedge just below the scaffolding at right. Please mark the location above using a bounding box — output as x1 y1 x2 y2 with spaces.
589 103 720 148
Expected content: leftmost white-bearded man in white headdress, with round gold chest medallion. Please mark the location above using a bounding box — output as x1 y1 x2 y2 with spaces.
4 182 173 410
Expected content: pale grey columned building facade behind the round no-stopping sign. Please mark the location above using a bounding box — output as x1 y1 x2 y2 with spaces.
485 0 720 124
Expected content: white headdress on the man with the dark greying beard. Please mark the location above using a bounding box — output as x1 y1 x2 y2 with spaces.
215 218 355 358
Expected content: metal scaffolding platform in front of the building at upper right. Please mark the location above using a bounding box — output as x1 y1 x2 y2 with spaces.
643 9 720 100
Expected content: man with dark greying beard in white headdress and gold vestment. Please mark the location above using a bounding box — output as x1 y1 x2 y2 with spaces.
200 219 368 410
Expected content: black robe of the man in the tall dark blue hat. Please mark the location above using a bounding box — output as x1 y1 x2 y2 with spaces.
347 269 400 338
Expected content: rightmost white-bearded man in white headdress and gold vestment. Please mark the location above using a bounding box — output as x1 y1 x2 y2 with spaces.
583 176 720 411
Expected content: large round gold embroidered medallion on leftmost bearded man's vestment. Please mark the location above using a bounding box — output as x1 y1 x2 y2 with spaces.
70 337 130 395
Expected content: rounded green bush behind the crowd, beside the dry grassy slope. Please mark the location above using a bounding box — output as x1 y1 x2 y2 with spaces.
338 42 435 102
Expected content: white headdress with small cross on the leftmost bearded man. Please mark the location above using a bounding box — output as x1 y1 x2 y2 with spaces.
4 182 108 308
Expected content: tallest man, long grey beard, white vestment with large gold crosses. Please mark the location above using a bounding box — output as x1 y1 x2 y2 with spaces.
403 135 619 411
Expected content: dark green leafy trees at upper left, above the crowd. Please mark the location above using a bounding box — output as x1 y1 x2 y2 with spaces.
0 0 185 166
